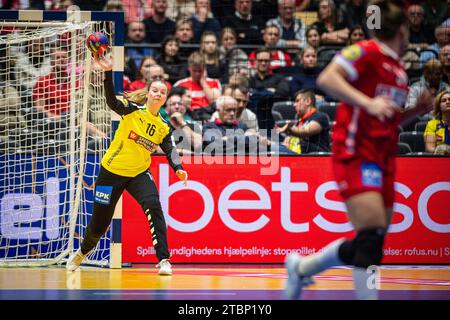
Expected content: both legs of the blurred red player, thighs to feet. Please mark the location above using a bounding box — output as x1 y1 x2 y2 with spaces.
285 192 386 299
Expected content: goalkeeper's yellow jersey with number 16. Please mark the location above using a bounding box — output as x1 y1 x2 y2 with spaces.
102 99 170 177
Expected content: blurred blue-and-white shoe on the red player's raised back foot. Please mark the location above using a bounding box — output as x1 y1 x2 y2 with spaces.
284 253 314 300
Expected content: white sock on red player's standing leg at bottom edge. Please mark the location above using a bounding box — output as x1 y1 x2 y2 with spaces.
353 267 379 300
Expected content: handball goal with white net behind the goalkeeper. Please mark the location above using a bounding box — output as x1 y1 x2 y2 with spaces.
0 10 124 268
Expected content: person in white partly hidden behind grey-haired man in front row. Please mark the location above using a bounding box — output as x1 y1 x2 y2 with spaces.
211 85 259 133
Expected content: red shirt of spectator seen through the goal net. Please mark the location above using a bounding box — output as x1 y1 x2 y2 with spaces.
33 72 79 115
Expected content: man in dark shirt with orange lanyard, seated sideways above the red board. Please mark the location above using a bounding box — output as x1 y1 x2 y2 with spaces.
276 89 330 154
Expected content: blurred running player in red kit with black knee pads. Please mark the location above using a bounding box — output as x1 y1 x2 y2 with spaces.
285 0 432 299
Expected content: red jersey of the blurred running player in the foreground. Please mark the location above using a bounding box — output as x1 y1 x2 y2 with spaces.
333 40 408 167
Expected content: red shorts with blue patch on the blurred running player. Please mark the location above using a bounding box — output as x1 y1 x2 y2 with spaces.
333 158 395 208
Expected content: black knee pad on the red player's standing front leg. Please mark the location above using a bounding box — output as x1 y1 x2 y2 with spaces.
353 228 386 268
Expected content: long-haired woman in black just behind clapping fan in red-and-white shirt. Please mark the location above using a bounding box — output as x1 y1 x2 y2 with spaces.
200 31 228 83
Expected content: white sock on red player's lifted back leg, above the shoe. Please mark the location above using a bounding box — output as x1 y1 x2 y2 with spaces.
298 238 345 276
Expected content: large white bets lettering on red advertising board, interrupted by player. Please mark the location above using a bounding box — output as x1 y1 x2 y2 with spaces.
159 164 450 233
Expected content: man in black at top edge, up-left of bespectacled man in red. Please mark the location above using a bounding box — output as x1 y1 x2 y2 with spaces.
222 0 265 44
